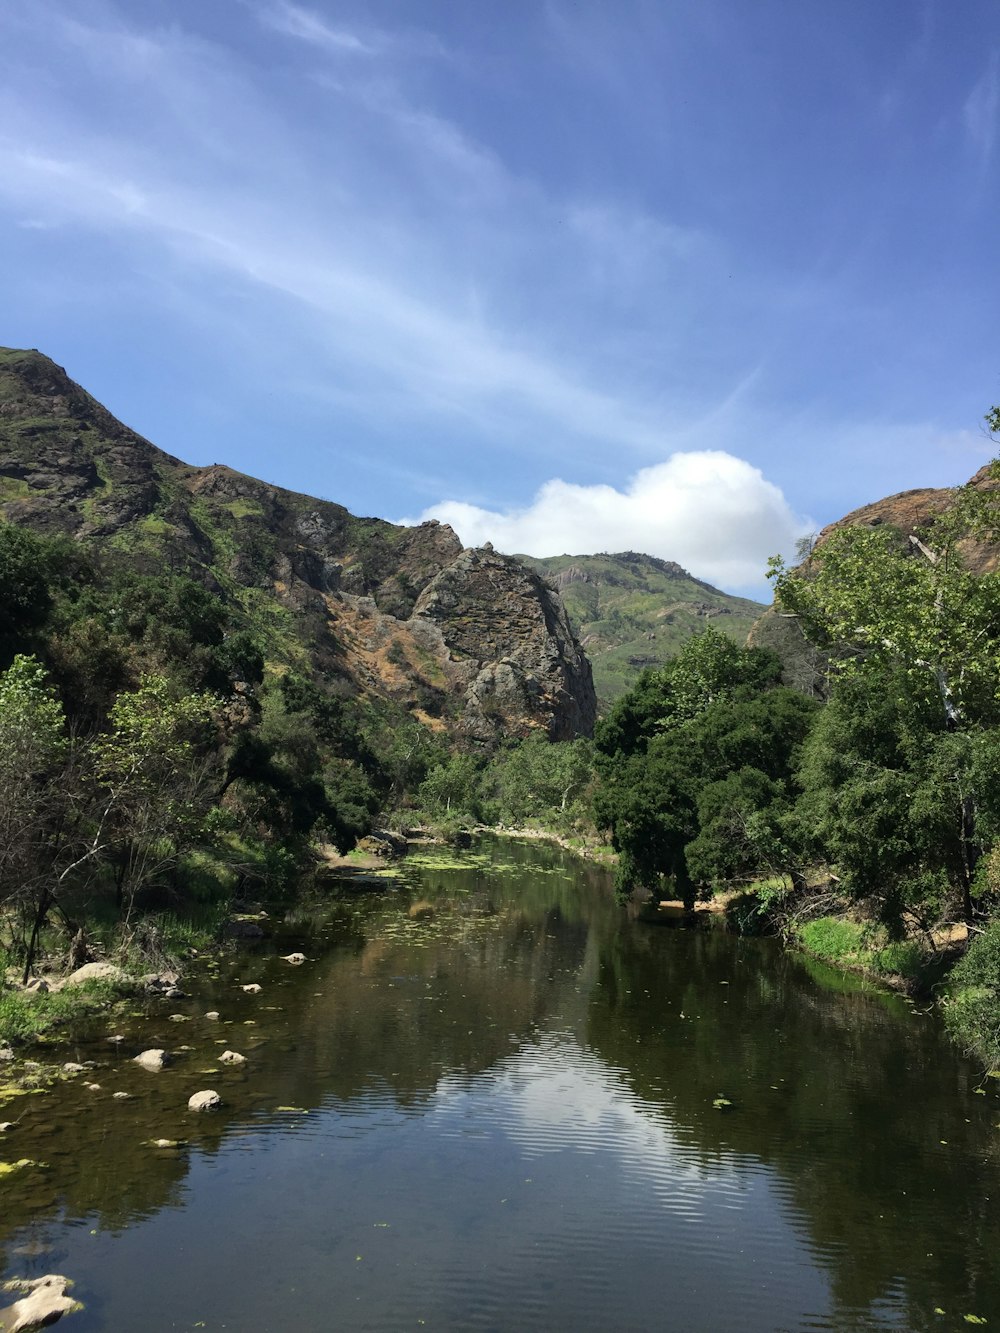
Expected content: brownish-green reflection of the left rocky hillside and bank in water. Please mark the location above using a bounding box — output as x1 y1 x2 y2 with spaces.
0 842 615 1273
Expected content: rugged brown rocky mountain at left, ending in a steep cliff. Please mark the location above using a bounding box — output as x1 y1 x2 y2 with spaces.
0 348 596 742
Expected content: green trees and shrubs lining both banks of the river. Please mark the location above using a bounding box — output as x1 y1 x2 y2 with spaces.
0 359 1000 1066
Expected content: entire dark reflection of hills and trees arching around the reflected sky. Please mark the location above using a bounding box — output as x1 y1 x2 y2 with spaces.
0 844 1000 1330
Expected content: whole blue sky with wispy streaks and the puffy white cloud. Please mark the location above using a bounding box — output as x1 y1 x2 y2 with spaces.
0 0 1000 596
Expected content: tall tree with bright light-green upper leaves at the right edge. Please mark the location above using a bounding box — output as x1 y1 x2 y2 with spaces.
771 471 1000 929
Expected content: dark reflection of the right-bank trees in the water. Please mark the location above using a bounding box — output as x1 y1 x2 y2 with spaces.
588 925 1000 1329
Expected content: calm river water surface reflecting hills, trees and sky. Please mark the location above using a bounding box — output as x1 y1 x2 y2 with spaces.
0 842 1000 1333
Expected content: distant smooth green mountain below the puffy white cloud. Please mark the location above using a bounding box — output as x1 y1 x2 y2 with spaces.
520 551 764 705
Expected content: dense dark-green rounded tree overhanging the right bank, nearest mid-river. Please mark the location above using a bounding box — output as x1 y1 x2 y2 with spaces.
595 631 816 904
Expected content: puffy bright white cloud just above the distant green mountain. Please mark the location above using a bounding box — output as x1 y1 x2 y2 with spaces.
403 449 811 588
